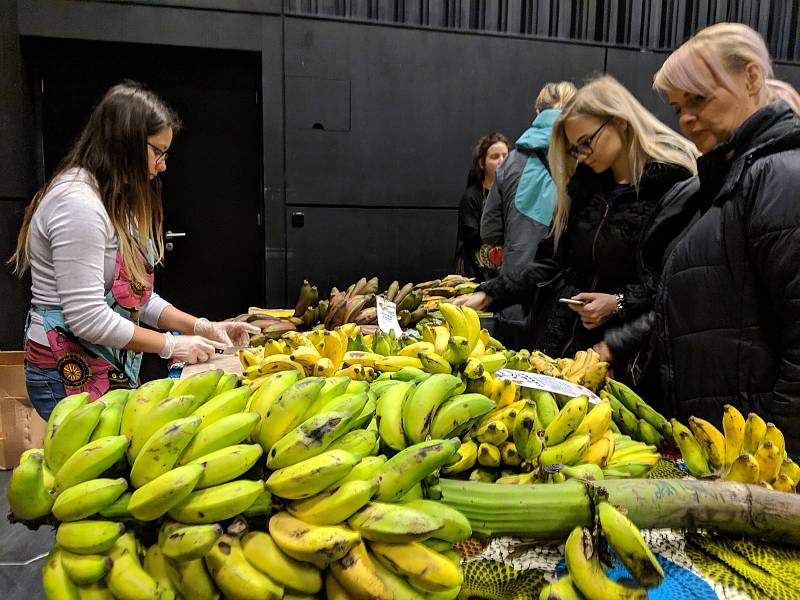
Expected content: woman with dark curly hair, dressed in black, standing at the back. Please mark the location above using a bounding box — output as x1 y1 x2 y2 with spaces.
456 131 508 281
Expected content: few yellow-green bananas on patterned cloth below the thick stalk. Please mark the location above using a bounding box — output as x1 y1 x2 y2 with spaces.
539 502 664 600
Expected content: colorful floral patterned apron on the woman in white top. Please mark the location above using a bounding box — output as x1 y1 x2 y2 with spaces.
25 252 154 400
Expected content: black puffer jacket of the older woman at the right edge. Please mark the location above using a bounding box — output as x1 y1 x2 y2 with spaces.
656 102 800 454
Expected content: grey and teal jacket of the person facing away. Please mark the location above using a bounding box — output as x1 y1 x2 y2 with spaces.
481 109 561 272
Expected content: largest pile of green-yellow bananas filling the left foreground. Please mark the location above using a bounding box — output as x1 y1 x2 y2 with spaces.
8 370 471 600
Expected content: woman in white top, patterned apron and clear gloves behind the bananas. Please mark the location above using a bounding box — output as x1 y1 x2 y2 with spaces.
10 82 252 419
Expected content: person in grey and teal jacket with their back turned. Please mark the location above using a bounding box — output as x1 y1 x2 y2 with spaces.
481 81 576 347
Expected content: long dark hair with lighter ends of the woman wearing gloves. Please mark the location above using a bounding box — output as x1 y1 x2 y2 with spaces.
9 81 180 283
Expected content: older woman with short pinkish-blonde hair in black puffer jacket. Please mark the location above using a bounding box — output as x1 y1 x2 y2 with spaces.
654 23 800 453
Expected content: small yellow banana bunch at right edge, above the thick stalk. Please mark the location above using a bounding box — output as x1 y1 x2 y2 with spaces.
672 404 800 492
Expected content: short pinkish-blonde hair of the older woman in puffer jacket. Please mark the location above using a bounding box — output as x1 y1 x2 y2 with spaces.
653 23 772 101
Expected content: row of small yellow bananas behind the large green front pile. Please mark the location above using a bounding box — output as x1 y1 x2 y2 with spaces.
238 304 508 385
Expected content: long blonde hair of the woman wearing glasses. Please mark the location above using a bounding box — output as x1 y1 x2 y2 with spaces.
550 75 698 247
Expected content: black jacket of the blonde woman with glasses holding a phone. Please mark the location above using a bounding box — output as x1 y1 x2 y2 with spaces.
480 162 691 356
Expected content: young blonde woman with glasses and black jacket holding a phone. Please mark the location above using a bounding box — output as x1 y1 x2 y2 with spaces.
462 76 696 366
